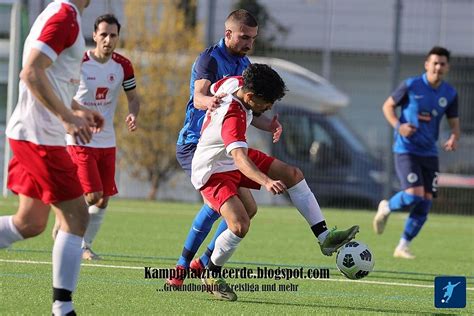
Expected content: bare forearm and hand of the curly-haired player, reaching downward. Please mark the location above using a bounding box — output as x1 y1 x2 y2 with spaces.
230 147 286 194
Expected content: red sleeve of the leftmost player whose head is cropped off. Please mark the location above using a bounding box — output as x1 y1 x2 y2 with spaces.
33 5 79 61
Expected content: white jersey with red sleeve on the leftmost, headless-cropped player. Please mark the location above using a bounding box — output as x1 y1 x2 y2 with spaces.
6 0 85 146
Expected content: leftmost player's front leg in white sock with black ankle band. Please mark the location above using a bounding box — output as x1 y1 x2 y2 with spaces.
53 195 89 315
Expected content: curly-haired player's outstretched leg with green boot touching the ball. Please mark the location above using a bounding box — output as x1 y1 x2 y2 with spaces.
264 151 359 256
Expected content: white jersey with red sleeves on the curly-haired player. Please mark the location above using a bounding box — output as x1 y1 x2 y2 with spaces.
191 76 253 189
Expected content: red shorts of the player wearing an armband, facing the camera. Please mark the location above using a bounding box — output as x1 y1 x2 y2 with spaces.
67 146 118 196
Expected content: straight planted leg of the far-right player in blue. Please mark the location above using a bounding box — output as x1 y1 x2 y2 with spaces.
394 157 439 259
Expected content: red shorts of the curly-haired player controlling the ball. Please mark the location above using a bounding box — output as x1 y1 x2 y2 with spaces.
200 148 275 213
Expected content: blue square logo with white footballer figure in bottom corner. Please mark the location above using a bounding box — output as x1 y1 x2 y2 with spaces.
434 276 466 308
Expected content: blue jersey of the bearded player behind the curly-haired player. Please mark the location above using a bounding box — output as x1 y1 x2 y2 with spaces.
177 39 250 145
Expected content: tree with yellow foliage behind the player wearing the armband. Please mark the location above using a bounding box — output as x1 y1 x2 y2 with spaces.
116 0 203 199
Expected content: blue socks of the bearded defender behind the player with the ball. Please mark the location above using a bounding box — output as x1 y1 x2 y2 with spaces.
177 204 220 268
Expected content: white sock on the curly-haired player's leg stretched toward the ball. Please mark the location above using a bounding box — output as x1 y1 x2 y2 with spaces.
288 179 324 226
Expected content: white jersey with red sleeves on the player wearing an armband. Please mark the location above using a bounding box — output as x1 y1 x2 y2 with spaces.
66 51 136 148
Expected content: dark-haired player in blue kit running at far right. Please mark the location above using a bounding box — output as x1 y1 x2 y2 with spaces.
373 46 460 259
